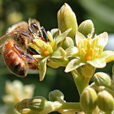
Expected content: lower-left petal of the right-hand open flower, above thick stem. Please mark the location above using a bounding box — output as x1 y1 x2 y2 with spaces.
65 58 85 72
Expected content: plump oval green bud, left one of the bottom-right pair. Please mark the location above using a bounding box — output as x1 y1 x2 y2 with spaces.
80 87 97 112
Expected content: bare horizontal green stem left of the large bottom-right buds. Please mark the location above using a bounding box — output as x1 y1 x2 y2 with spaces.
61 102 82 112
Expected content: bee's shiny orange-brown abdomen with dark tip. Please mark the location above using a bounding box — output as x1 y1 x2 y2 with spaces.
3 40 28 77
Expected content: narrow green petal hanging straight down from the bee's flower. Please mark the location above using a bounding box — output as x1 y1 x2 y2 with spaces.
39 57 48 81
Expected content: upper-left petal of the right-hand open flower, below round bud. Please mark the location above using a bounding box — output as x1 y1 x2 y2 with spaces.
76 31 86 47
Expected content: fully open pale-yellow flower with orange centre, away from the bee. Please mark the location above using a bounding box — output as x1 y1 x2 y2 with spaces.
65 32 114 72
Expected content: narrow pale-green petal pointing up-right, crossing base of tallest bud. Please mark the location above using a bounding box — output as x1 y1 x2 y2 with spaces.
55 28 72 47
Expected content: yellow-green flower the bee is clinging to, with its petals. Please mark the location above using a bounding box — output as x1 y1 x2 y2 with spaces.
29 29 71 81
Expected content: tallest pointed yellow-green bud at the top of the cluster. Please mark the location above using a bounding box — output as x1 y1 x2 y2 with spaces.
57 3 78 38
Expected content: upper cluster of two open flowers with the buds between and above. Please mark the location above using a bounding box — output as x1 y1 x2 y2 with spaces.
29 3 114 80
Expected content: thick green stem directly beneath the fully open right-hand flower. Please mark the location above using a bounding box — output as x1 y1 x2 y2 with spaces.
72 71 90 94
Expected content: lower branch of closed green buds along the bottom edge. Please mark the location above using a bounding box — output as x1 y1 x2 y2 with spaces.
15 72 114 114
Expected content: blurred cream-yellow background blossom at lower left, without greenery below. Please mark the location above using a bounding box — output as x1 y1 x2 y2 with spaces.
3 80 34 104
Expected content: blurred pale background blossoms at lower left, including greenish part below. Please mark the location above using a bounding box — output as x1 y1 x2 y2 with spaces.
3 80 34 114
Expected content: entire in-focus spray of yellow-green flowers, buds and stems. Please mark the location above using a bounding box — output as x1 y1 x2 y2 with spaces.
5 3 114 114
